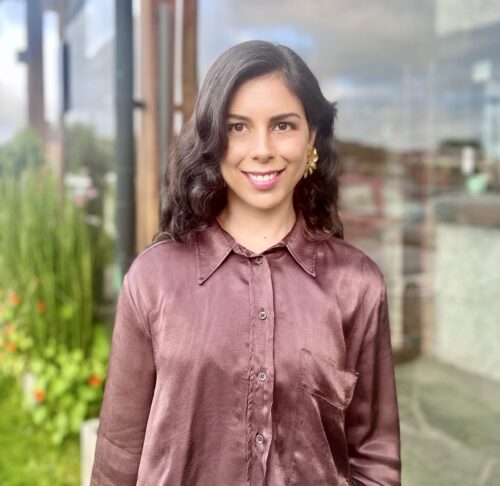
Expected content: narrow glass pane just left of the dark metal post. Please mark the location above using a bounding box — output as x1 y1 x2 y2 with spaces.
63 0 118 301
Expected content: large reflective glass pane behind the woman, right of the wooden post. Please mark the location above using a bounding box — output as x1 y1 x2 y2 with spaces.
198 0 500 485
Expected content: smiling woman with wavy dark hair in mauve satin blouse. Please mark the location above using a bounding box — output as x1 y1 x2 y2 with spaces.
92 41 400 486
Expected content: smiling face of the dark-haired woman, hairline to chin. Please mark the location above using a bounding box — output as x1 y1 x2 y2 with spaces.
221 74 315 215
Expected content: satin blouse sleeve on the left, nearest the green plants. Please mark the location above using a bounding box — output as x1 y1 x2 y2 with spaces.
91 276 156 486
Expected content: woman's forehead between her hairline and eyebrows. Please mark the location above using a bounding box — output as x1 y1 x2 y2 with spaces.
228 73 304 115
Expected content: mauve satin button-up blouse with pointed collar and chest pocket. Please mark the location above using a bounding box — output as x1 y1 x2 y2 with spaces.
91 215 401 486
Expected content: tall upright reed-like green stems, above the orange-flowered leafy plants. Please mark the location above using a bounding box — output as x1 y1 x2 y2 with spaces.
0 167 93 355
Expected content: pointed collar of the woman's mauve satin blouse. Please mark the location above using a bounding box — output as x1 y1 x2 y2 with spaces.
195 213 318 285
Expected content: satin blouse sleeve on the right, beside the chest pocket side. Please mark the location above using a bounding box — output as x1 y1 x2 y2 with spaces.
345 282 401 486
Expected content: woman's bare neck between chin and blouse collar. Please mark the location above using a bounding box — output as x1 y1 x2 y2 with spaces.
217 198 296 253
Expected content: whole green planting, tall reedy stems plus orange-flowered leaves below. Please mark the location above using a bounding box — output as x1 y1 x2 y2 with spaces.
0 131 111 444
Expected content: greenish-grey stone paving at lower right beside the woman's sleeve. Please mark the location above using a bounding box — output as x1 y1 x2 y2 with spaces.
396 358 500 486
